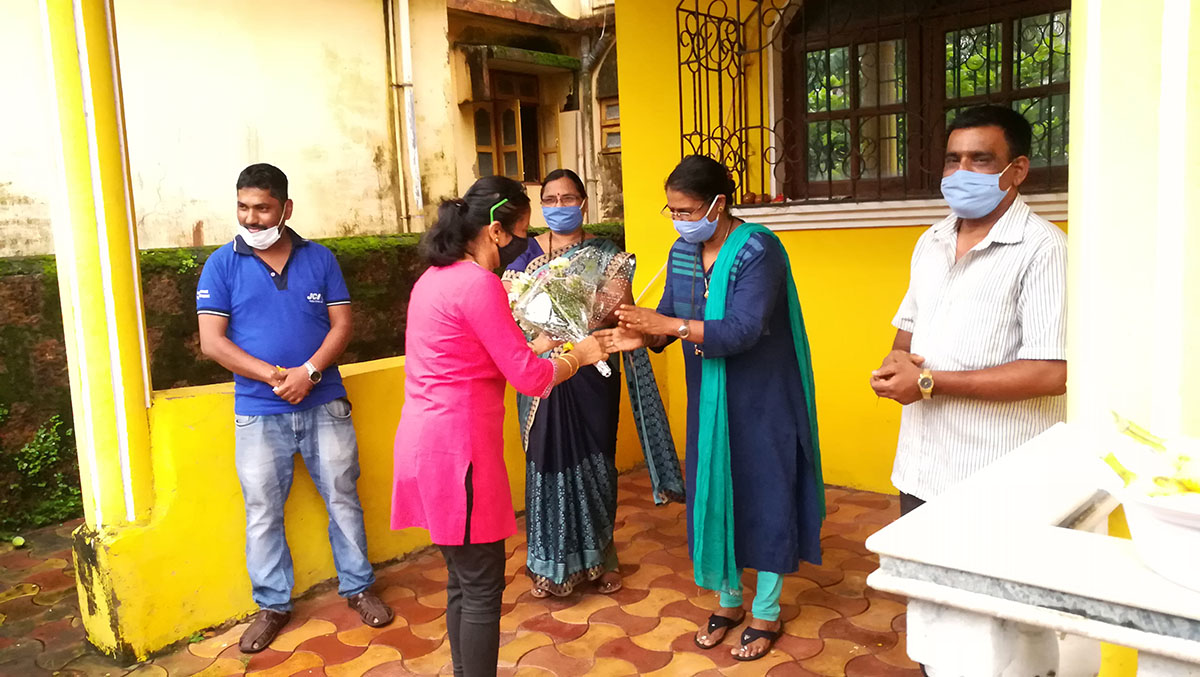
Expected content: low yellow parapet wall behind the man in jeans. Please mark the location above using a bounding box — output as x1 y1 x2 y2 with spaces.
91 358 657 657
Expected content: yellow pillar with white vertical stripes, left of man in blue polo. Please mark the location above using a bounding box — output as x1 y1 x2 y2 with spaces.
42 0 151 654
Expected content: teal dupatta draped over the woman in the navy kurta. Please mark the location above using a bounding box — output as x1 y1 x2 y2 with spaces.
692 223 826 592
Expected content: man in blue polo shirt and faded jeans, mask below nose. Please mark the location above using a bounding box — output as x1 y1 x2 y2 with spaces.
196 164 394 653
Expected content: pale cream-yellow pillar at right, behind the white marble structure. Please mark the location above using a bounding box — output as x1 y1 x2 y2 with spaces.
1068 0 1200 677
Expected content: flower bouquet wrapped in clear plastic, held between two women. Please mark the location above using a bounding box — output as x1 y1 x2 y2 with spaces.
509 248 634 377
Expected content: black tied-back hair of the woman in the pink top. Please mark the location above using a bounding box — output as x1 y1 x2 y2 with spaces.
420 175 529 266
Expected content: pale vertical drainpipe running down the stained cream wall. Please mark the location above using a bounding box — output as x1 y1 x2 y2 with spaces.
384 0 425 233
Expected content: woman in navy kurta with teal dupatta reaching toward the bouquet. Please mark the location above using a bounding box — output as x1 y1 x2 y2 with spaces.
596 155 824 660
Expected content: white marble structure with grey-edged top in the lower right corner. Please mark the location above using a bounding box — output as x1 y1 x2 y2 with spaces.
866 424 1200 677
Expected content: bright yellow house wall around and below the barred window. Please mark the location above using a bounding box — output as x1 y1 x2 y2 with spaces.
617 0 923 493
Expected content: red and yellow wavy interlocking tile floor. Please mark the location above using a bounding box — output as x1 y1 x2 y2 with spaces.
0 471 919 677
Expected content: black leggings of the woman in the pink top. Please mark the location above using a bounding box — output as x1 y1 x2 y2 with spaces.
438 467 505 677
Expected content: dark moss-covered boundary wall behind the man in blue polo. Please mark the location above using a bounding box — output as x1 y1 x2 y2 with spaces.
0 223 624 537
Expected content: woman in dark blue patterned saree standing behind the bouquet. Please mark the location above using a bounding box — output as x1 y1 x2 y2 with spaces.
506 169 683 598
